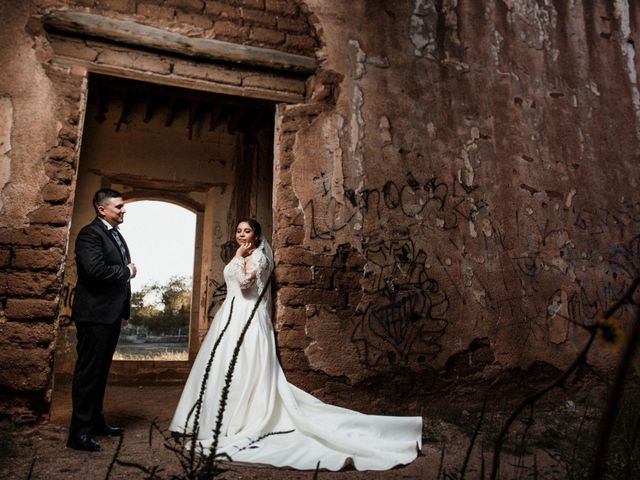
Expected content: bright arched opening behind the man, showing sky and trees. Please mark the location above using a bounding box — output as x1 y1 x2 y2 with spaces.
114 200 196 361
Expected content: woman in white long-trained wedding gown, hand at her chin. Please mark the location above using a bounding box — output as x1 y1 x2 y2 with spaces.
169 219 422 470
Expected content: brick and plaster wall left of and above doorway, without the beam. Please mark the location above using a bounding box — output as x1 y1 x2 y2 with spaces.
0 0 317 421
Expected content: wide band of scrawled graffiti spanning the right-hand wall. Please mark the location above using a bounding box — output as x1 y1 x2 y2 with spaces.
294 155 640 369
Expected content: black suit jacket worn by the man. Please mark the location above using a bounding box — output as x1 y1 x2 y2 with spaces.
71 218 131 324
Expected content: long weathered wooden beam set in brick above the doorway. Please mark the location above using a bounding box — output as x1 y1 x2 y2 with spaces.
43 11 317 74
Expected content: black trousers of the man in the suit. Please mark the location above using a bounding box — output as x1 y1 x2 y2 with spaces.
69 320 122 435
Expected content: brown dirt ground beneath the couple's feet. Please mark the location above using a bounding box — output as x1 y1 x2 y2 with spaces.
0 385 562 480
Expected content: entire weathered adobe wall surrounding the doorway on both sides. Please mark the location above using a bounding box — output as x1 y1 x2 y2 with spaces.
0 0 640 419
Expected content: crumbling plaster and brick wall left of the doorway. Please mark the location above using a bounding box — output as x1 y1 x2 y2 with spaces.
0 2 84 420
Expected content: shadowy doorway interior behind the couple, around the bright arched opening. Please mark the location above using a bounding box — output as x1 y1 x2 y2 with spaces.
55 74 275 382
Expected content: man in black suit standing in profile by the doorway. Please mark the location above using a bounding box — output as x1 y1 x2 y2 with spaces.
67 188 137 452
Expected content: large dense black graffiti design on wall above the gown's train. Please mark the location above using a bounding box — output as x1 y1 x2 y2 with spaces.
351 238 449 369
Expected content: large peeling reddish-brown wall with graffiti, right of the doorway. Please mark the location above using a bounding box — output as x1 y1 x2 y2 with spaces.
274 0 640 412
